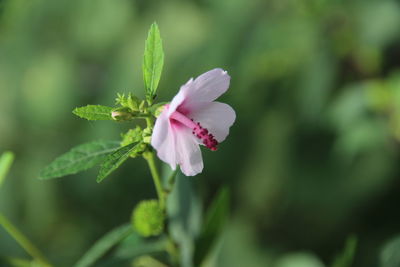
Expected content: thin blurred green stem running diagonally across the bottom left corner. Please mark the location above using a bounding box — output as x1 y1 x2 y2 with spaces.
0 213 52 267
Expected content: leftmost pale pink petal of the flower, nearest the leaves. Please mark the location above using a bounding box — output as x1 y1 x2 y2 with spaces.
151 108 177 170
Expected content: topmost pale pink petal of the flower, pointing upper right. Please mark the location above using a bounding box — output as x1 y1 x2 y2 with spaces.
181 69 231 107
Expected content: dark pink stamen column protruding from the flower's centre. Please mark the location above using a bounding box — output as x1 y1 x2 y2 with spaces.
170 111 218 151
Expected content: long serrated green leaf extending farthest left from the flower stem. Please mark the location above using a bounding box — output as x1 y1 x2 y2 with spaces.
39 141 119 179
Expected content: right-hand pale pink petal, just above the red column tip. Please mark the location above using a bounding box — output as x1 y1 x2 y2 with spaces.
189 102 236 142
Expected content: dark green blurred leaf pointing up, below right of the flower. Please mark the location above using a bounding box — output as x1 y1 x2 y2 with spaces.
194 188 230 266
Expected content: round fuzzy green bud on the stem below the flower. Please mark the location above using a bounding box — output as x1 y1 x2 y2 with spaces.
131 199 165 237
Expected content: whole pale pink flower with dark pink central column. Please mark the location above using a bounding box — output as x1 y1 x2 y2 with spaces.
151 69 236 176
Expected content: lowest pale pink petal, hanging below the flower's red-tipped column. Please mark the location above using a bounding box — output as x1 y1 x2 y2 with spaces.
176 127 203 176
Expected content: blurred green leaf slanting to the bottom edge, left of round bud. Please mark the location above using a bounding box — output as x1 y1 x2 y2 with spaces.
75 224 133 267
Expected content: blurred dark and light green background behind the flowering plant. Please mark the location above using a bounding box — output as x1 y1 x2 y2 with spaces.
0 0 400 267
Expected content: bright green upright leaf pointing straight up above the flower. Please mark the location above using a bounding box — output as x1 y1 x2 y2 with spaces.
143 22 164 104
